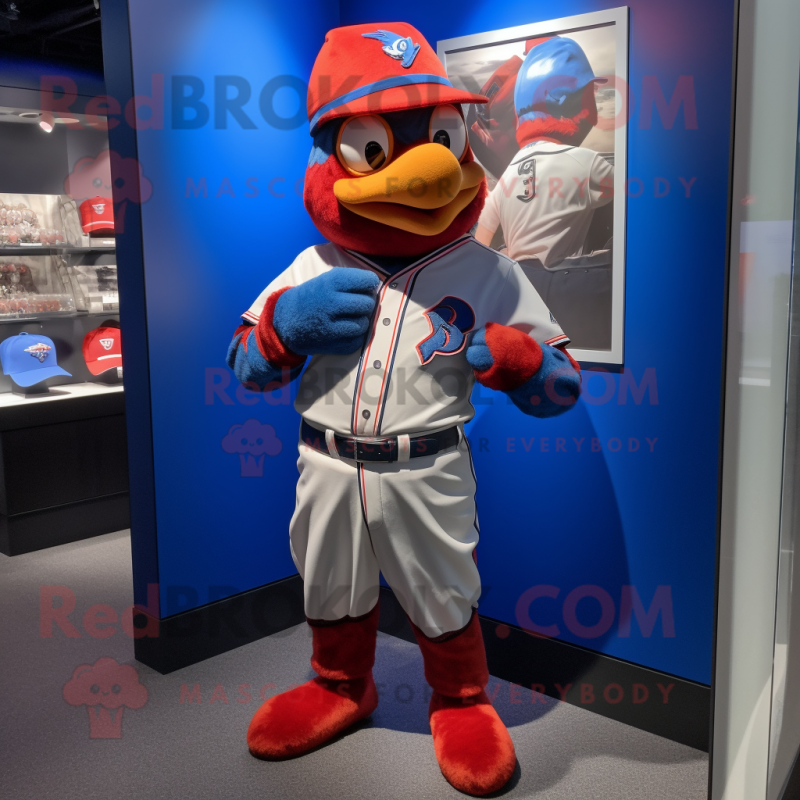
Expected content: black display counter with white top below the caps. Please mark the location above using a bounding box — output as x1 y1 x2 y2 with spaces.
0 383 130 556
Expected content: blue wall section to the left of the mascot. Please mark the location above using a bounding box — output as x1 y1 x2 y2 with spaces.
122 0 338 616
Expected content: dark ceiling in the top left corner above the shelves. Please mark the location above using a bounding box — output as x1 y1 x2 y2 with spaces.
0 0 103 73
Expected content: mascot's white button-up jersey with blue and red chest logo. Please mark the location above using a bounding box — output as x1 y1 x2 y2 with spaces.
243 235 569 436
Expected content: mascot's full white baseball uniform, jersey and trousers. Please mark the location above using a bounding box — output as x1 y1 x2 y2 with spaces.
243 236 568 637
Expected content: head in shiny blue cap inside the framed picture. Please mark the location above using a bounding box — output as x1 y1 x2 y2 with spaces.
514 36 608 147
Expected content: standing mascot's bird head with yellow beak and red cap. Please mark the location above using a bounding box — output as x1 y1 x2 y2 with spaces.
304 22 486 256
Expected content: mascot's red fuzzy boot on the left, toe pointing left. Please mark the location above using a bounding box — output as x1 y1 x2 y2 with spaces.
247 606 378 760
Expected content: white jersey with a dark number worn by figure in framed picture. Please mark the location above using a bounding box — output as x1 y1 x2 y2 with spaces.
478 142 614 267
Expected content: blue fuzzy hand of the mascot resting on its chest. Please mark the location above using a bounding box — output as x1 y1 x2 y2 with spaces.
272 267 380 355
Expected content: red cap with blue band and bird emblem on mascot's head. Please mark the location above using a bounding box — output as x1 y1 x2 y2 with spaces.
308 22 486 136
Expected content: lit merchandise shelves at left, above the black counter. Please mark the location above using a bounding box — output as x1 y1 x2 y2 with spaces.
0 101 122 402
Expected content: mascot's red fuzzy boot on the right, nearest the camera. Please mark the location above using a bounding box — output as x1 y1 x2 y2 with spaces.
412 611 517 795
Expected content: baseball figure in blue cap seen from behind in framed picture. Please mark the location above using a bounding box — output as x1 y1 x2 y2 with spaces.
475 36 614 349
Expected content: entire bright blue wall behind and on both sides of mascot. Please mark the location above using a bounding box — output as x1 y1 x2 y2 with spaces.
120 0 733 683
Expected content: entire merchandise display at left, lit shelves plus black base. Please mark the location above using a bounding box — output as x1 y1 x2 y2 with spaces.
0 94 130 555
